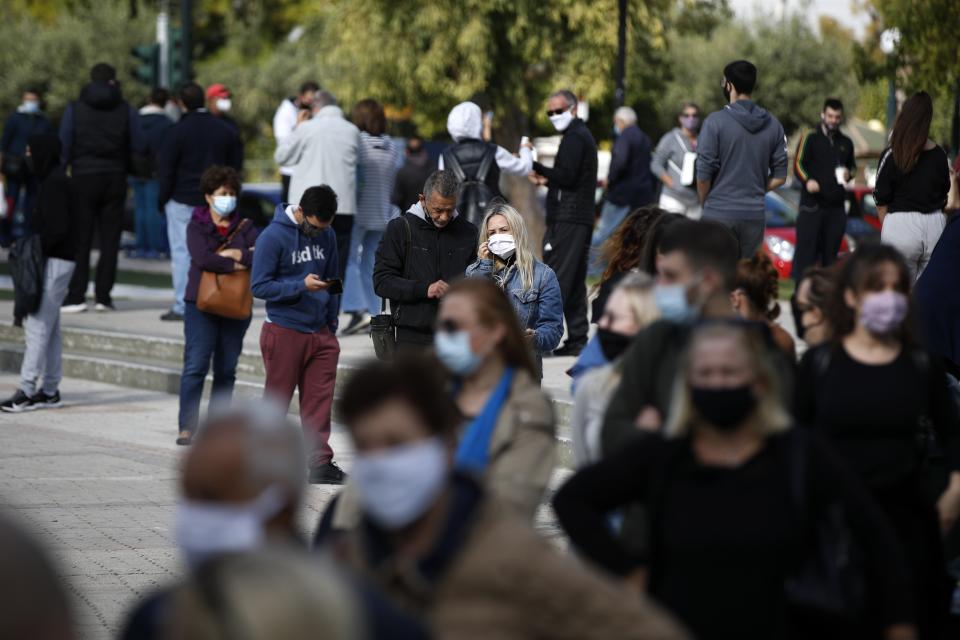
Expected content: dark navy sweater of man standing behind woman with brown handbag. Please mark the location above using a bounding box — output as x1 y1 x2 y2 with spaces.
158 110 243 207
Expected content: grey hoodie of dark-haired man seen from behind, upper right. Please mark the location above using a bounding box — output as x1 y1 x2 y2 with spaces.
697 100 787 220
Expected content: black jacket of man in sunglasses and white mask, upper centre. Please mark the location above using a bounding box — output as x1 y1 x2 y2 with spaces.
533 118 597 226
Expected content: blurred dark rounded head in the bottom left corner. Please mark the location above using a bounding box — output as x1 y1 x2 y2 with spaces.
0 516 78 640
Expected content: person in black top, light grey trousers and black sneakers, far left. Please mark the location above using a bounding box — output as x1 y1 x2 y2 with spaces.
0 134 78 413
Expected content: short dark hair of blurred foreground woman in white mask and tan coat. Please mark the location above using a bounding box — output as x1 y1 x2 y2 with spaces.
340 356 459 438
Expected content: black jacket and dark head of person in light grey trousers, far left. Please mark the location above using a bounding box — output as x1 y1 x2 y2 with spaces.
27 133 77 262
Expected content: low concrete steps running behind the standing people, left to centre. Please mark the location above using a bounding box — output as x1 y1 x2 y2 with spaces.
0 324 573 467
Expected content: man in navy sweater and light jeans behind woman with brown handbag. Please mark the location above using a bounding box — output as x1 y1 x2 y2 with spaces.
158 82 243 321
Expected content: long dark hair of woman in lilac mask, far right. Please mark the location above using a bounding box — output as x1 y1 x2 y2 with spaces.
826 244 917 347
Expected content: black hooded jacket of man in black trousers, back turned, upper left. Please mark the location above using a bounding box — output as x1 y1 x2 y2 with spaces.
60 82 144 176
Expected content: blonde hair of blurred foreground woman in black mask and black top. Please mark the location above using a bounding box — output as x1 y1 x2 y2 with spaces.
663 323 792 438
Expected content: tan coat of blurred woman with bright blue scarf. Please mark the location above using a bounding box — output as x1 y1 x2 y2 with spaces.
333 371 557 530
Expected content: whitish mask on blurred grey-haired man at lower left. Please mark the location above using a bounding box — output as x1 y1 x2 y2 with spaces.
174 487 286 567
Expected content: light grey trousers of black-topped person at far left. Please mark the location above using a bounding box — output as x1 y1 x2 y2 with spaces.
20 258 76 396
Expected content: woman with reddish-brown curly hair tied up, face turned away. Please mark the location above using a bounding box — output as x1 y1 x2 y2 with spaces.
730 253 797 362
